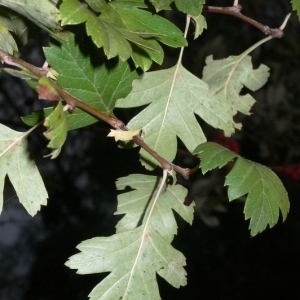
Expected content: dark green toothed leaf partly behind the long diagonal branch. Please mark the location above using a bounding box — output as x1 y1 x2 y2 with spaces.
22 34 138 130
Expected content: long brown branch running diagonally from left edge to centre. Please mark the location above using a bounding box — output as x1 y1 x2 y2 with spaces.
0 49 193 179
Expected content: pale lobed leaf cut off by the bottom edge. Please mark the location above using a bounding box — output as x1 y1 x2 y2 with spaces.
66 226 186 300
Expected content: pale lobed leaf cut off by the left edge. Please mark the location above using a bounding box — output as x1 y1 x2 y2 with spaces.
0 124 48 216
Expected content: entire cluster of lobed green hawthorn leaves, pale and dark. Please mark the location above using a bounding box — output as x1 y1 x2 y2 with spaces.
0 0 300 299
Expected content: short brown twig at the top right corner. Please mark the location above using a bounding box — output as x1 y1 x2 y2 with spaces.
203 5 284 39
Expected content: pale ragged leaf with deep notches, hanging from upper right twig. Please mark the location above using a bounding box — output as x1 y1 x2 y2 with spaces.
203 54 269 118
